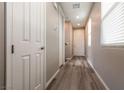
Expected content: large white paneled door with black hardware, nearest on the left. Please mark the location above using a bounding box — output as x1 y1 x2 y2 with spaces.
7 2 44 89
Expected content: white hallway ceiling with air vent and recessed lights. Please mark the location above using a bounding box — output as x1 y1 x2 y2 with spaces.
60 2 93 28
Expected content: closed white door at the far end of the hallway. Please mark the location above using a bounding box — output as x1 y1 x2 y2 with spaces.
73 29 84 56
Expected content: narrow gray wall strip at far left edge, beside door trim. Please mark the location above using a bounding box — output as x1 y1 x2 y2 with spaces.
0 3 5 89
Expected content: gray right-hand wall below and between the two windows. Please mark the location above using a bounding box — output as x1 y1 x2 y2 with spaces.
87 3 124 89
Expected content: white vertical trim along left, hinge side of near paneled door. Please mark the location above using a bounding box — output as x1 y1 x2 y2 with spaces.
6 3 13 89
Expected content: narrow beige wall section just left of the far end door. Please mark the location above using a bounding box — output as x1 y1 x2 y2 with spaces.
65 22 73 58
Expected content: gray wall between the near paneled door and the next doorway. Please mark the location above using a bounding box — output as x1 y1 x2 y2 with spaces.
46 3 59 82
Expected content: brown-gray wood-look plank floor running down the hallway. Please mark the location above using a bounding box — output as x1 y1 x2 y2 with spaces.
47 57 105 90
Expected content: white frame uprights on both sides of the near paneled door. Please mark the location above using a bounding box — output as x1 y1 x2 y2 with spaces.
5 2 46 90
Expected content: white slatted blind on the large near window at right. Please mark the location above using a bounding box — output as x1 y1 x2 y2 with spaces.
102 3 124 46
